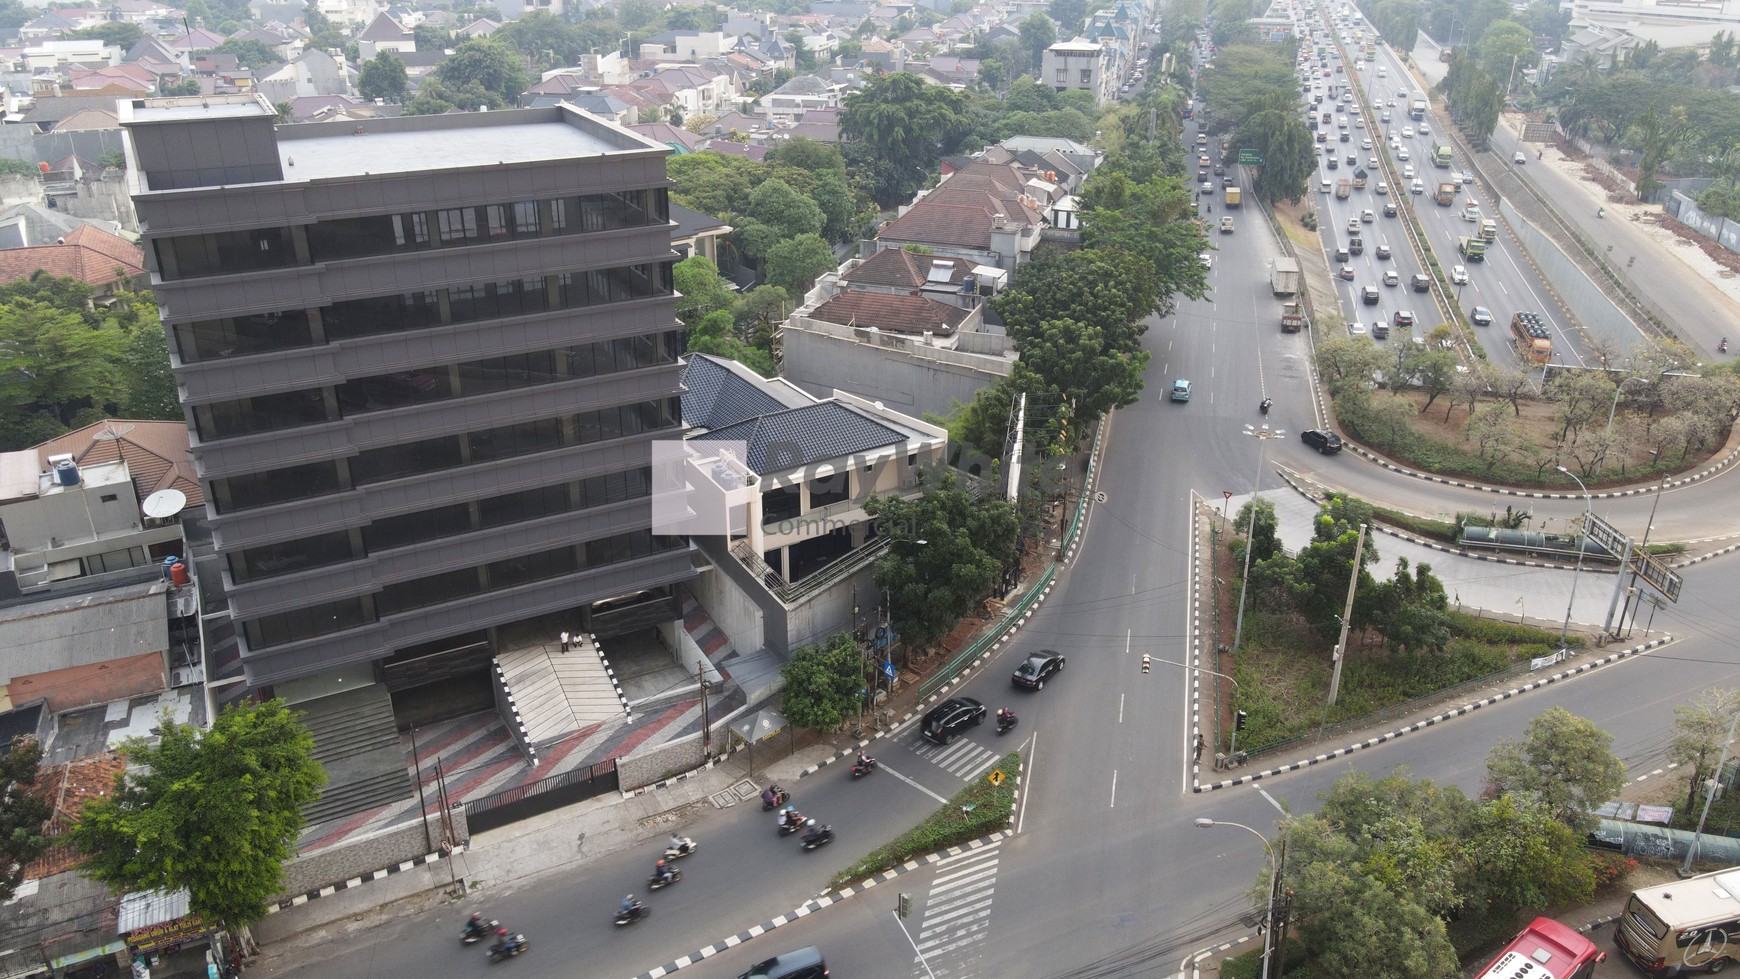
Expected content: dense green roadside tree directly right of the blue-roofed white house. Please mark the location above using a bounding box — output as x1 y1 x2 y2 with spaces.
865 473 1020 645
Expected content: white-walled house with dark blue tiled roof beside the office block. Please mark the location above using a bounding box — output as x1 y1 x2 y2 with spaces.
682 355 948 654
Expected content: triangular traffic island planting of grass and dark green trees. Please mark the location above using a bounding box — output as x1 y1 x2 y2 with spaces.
1215 494 1576 751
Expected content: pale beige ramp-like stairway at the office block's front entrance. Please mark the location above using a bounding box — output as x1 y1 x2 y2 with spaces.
496 636 628 748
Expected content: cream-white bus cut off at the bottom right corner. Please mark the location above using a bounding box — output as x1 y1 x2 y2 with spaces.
1613 868 1740 979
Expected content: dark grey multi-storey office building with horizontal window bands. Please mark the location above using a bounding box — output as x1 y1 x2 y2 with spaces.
122 96 694 747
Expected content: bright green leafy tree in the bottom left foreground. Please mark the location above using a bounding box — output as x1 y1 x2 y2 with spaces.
71 699 325 929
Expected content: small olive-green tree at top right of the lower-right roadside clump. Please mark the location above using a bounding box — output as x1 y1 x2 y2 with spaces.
1486 708 1625 833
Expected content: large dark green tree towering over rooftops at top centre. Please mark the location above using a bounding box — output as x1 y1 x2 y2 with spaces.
840 71 967 205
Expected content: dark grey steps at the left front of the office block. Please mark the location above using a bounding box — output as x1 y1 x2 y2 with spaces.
294 683 414 826
